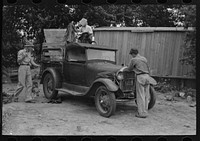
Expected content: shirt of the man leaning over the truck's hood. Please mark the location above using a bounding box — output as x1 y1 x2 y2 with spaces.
128 54 149 74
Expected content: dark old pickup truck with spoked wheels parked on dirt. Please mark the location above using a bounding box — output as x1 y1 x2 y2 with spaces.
40 28 156 117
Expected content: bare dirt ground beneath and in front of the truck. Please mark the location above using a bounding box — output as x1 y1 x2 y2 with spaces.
2 84 196 135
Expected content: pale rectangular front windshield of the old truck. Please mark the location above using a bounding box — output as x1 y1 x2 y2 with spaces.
87 49 115 62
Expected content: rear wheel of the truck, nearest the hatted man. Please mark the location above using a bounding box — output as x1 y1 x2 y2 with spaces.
43 73 58 99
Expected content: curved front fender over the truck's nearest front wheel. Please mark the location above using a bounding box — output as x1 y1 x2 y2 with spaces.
91 78 119 92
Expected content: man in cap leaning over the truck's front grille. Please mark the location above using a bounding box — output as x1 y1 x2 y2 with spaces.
126 49 157 118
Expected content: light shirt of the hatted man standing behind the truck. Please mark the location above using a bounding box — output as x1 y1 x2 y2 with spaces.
17 49 31 65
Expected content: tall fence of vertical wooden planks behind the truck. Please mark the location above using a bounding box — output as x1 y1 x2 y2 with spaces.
94 27 193 77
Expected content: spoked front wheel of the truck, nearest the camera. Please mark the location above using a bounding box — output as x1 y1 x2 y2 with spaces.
95 86 116 117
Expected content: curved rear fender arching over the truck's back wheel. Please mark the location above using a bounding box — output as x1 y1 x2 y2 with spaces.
40 68 62 88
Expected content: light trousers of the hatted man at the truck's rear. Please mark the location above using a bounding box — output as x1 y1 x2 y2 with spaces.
14 65 33 101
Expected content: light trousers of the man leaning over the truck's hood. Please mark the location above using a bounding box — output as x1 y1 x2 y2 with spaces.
136 74 150 115
